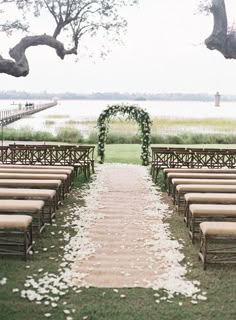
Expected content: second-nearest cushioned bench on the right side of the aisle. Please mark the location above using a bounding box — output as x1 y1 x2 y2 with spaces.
189 204 236 243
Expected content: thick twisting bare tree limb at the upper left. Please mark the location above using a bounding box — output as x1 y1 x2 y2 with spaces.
0 34 77 77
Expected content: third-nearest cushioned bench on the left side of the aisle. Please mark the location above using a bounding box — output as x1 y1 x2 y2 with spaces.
0 188 57 223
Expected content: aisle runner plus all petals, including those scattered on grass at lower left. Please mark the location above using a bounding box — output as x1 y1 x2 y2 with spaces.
18 164 205 312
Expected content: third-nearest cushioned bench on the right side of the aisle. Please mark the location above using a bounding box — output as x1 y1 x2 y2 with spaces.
184 193 236 226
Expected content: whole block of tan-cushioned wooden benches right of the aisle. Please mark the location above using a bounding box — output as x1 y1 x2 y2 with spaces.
163 168 236 269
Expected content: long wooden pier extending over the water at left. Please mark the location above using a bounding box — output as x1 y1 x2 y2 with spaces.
0 101 57 127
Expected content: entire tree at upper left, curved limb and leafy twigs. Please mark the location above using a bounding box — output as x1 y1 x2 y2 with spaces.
0 0 138 77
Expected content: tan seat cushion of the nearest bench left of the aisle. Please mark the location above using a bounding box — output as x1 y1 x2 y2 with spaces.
0 214 32 230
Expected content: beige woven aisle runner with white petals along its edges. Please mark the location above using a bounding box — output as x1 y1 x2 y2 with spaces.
71 164 199 296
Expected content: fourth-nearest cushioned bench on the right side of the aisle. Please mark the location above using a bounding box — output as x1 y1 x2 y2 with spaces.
175 184 236 212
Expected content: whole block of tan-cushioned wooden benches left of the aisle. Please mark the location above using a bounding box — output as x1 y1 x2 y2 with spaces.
0 164 74 259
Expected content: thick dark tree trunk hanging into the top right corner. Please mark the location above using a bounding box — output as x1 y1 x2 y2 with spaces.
200 0 236 59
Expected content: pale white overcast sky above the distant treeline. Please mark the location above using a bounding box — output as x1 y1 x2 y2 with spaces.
0 0 236 94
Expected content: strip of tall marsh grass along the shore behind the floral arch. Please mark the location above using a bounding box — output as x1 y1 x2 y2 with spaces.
4 115 236 144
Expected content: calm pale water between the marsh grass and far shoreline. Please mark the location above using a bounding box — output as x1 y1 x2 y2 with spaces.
0 100 236 132
